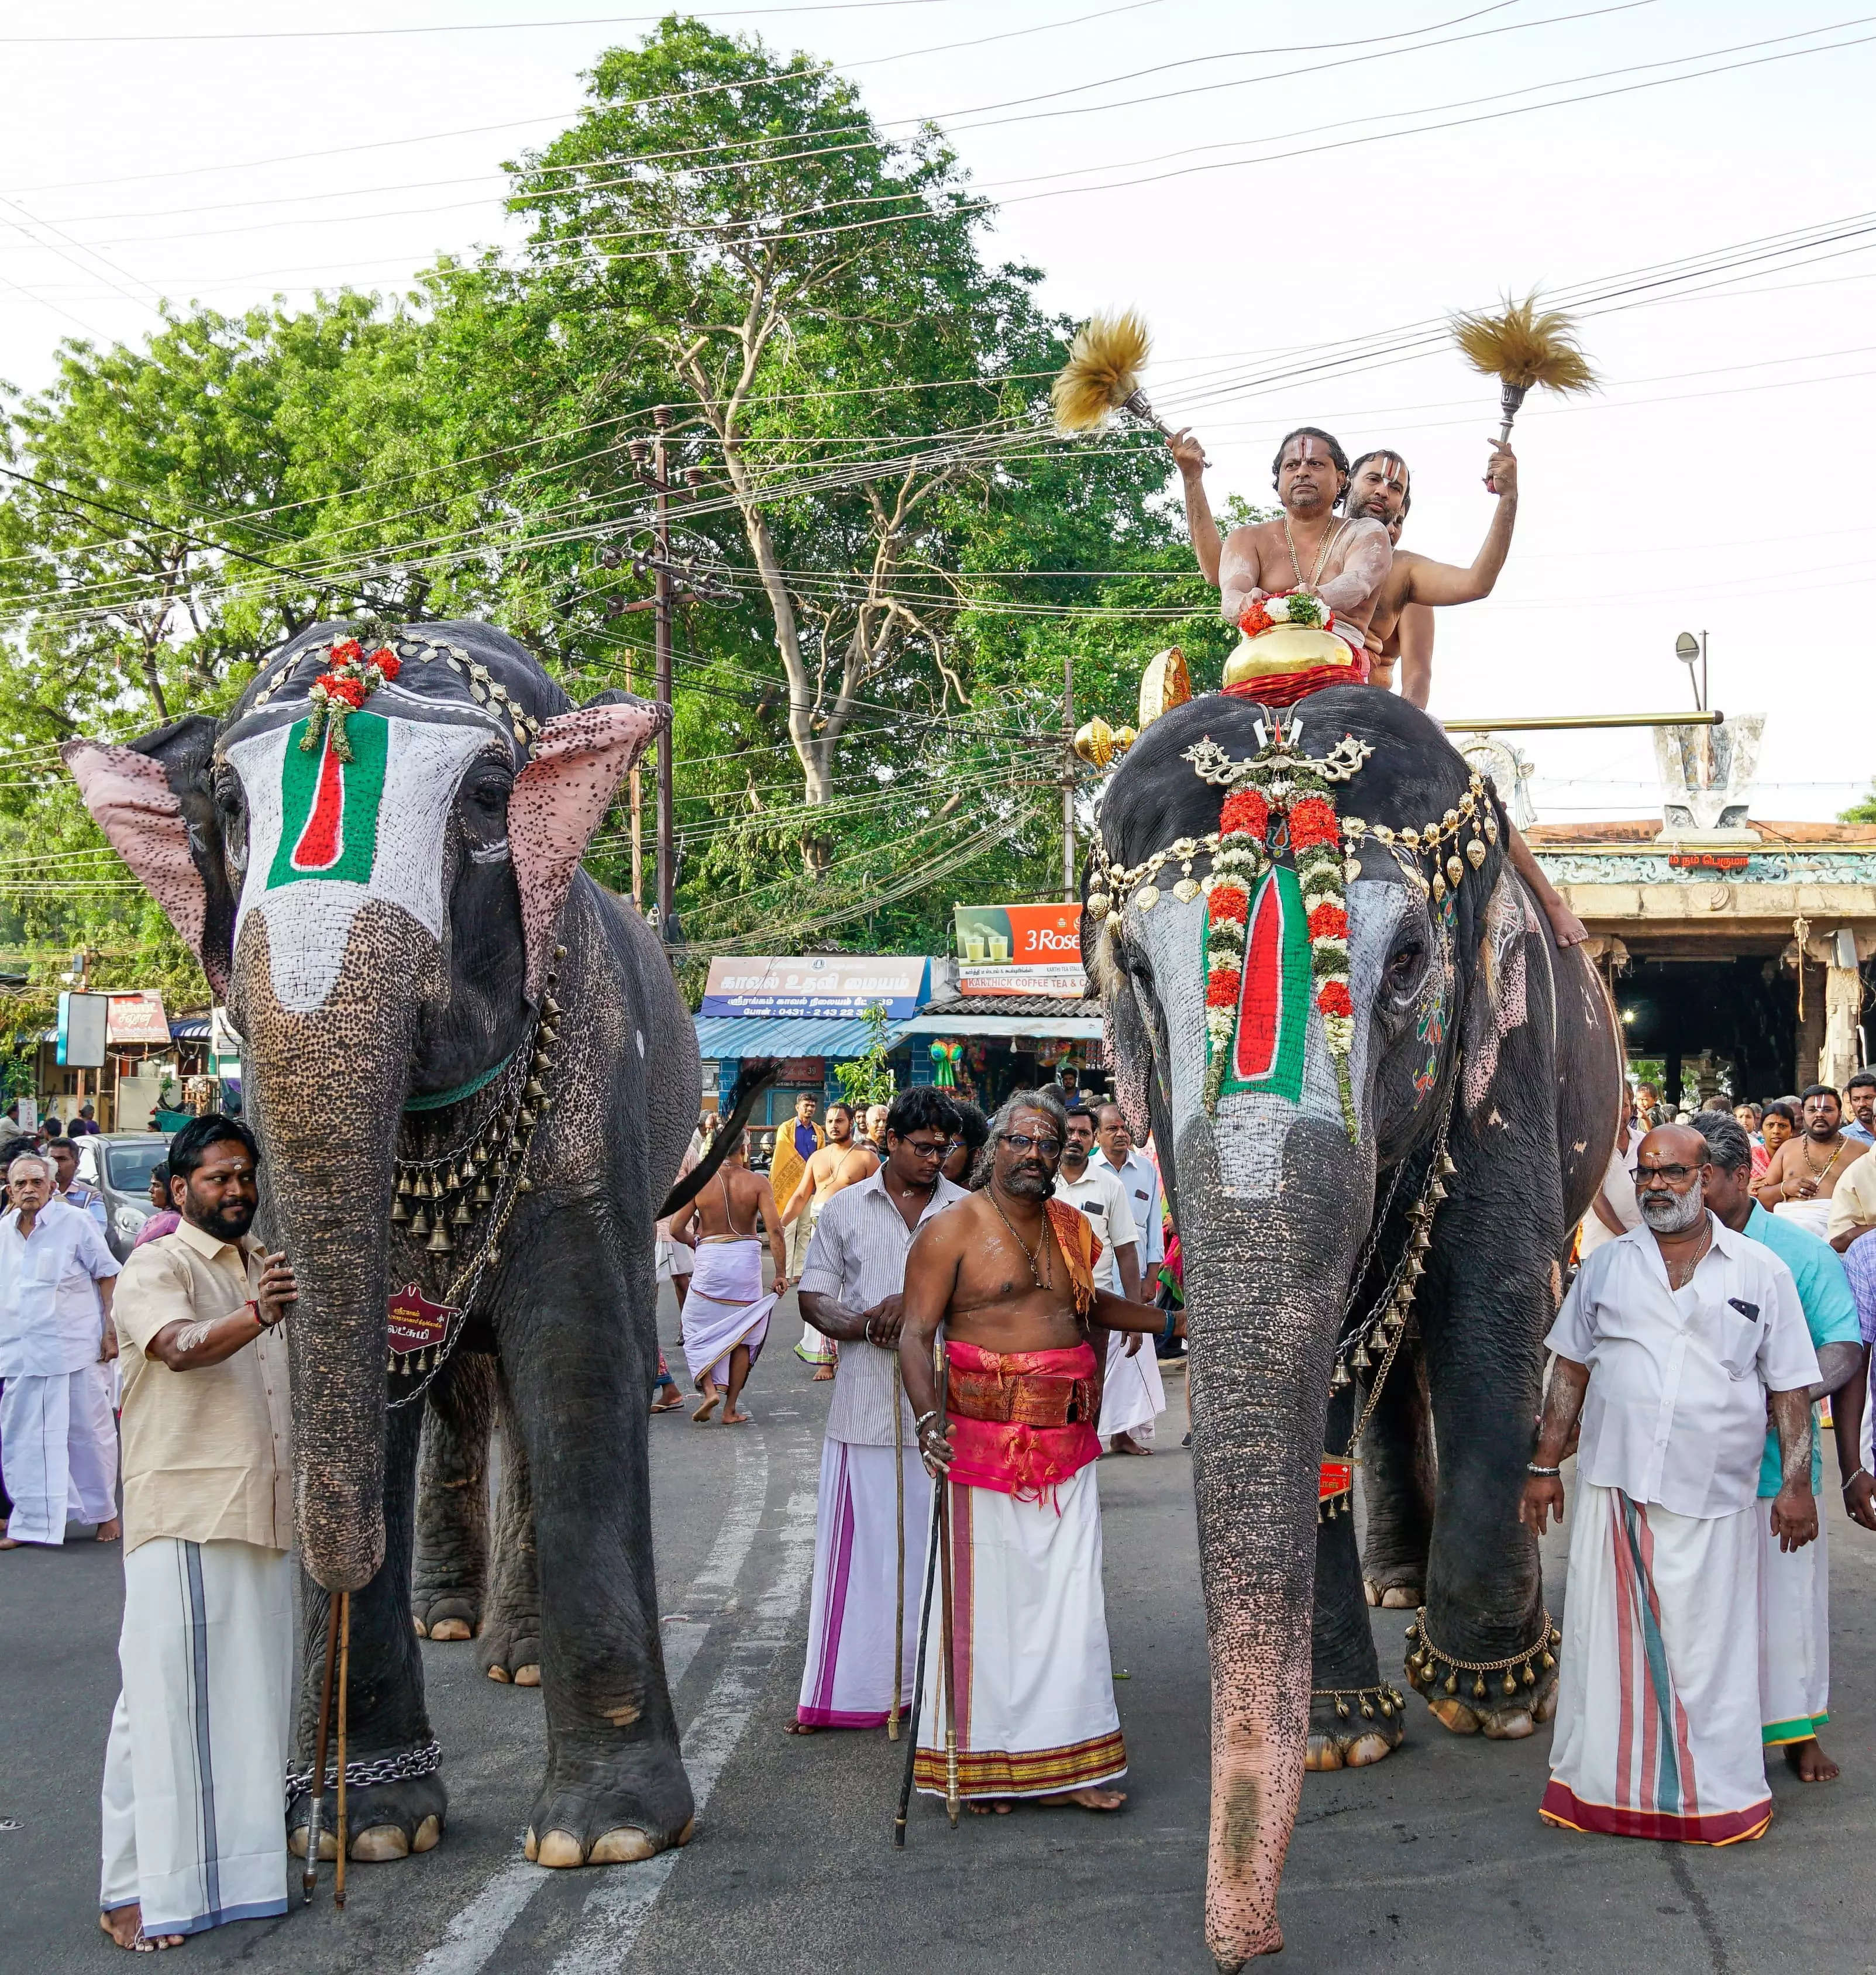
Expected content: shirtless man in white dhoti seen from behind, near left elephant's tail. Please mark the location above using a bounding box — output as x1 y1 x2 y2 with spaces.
683 1138 788 1426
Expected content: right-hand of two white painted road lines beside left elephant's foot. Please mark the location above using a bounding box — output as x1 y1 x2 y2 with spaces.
553 1437 820 1975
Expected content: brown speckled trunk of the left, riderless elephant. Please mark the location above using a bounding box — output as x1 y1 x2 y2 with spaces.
235 900 440 1592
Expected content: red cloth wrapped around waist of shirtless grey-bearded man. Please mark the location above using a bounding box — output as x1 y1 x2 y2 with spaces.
946 1343 1100 1505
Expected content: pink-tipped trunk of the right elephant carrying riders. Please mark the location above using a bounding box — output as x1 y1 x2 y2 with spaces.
1179 1118 1372 1969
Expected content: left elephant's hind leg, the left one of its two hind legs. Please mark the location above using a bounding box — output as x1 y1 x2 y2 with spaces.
411 1351 495 1639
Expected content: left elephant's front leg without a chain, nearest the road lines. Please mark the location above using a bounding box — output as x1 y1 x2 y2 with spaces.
500 1210 693 1866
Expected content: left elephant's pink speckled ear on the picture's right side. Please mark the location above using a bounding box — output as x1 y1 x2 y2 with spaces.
508 693 672 1002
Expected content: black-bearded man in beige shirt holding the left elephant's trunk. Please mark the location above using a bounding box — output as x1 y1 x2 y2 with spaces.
99 1114 296 1949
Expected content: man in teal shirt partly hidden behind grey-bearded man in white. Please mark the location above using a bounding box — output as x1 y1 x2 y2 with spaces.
1694 1112 1868 1784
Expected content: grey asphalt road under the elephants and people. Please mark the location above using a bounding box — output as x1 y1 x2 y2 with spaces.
11 1299 1876 1975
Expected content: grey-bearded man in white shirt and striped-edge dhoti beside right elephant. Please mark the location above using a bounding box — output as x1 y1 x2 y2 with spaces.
1519 1126 1819 1845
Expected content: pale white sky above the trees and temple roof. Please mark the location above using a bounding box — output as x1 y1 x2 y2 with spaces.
0 0 1876 821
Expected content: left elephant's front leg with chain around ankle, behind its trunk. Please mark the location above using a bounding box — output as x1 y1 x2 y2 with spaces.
286 1406 448 1860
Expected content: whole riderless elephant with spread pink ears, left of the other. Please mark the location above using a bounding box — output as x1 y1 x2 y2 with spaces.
63 622 699 1864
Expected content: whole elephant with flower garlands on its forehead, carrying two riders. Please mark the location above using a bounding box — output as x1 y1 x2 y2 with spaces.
1082 685 1622 1967
